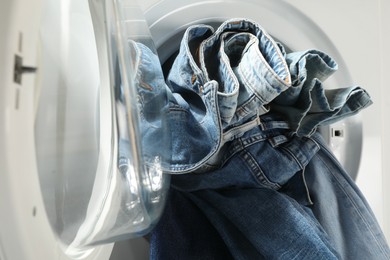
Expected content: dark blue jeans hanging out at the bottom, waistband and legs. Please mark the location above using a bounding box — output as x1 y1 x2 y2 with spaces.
151 123 390 260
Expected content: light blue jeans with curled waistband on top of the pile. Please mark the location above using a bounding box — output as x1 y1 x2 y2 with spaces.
167 19 290 173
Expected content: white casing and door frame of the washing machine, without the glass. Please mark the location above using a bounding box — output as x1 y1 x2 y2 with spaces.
0 0 390 260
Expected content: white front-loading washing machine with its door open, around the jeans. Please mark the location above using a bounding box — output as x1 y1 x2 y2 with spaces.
0 0 390 260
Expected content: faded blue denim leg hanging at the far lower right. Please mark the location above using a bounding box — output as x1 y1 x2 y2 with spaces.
305 133 390 260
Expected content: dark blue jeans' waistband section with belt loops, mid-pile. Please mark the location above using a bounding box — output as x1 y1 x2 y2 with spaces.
175 114 319 186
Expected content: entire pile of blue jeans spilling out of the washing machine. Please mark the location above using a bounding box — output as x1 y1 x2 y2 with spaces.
131 19 390 259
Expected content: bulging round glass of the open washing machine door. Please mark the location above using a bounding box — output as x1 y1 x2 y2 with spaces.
35 0 170 257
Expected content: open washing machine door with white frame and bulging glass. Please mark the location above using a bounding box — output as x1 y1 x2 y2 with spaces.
0 0 170 260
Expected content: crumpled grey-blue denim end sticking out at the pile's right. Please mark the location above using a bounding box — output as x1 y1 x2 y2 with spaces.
271 50 372 136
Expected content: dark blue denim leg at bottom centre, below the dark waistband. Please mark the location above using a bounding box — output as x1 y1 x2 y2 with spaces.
150 188 340 260
